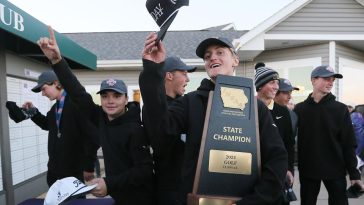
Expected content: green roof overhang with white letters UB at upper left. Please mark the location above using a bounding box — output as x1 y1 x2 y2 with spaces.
0 1 97 70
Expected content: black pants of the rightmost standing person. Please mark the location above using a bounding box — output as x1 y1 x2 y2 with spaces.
300 176 349 205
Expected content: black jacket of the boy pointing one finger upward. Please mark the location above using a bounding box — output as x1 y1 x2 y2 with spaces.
53 60 153 205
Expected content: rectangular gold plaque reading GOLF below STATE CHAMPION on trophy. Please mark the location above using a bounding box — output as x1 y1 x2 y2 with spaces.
209 150 252 175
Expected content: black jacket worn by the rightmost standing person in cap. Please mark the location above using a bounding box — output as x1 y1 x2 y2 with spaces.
294 93 360 180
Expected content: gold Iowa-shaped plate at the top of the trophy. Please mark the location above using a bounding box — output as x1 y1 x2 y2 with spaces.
221 86 248 110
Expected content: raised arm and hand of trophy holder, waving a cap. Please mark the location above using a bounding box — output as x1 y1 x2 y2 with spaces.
139 33 187 149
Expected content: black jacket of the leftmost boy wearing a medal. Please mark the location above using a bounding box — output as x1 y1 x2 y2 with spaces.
31 95 98 186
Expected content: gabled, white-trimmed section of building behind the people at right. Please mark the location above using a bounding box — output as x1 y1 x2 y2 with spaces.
236 0 364 104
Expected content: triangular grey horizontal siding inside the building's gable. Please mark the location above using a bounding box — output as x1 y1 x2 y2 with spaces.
267 0 364 34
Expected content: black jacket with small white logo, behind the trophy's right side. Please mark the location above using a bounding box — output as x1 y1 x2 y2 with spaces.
270 103 295 174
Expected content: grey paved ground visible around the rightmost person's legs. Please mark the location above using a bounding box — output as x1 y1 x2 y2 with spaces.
290 167 364 205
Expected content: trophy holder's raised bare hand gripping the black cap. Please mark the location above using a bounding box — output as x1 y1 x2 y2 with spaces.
142 32 166 63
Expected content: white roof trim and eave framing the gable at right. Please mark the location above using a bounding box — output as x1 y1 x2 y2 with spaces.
233 0 364 61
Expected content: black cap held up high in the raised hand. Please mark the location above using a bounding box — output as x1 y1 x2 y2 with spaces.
145 0 189 40
